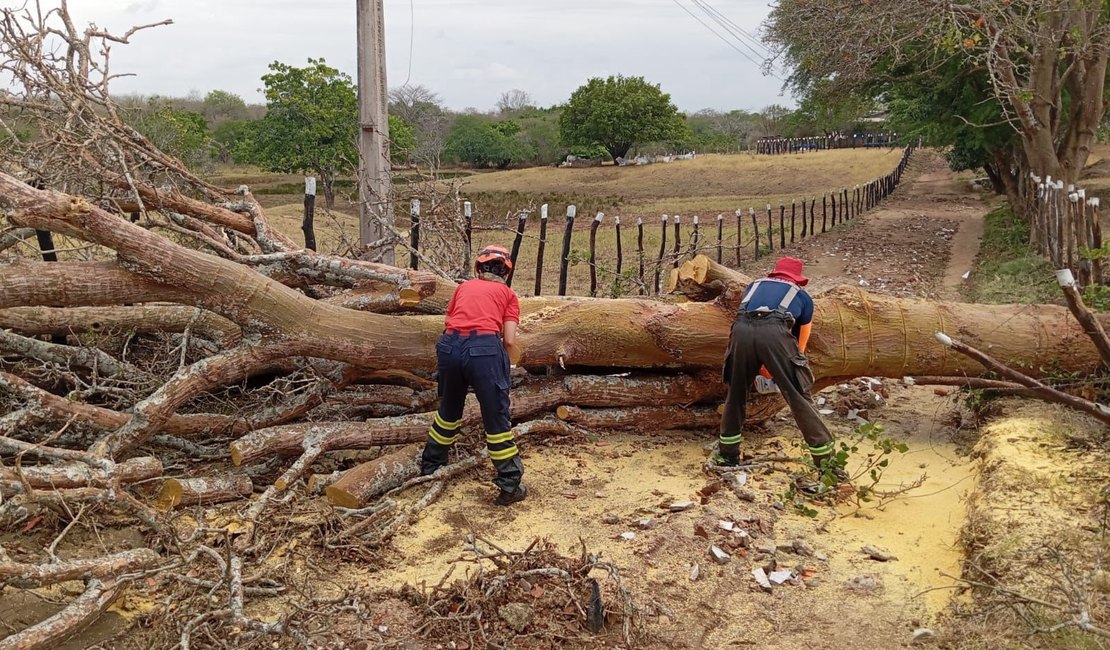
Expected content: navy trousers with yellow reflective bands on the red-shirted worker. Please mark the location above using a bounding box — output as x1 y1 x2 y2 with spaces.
421 333 524 491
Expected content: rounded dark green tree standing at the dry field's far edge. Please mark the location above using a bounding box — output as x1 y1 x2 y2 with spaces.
559 75 684 160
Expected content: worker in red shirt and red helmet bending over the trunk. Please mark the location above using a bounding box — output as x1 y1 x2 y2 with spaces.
421 246 527 506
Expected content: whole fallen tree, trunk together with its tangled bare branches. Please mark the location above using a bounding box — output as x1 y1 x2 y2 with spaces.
0 6 1098 649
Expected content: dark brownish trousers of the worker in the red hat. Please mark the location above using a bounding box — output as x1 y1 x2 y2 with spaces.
719 311 834 456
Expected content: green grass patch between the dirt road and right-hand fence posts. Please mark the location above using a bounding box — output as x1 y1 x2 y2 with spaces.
965 205 1063 304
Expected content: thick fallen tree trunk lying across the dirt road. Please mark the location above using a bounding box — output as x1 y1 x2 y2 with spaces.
0 174 1110 388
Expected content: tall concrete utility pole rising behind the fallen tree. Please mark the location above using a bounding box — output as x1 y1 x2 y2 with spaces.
356 0 394 264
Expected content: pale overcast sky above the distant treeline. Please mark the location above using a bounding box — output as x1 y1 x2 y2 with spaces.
60 0 793 111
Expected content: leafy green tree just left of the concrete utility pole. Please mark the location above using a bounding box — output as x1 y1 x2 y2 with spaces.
250 59 359 207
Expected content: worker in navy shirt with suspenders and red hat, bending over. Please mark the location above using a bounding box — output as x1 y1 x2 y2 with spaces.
713 257 845 478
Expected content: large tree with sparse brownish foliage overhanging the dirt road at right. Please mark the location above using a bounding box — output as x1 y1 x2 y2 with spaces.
766 0 1110 181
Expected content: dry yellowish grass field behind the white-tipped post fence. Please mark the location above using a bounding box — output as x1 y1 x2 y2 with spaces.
251 149 901 296
